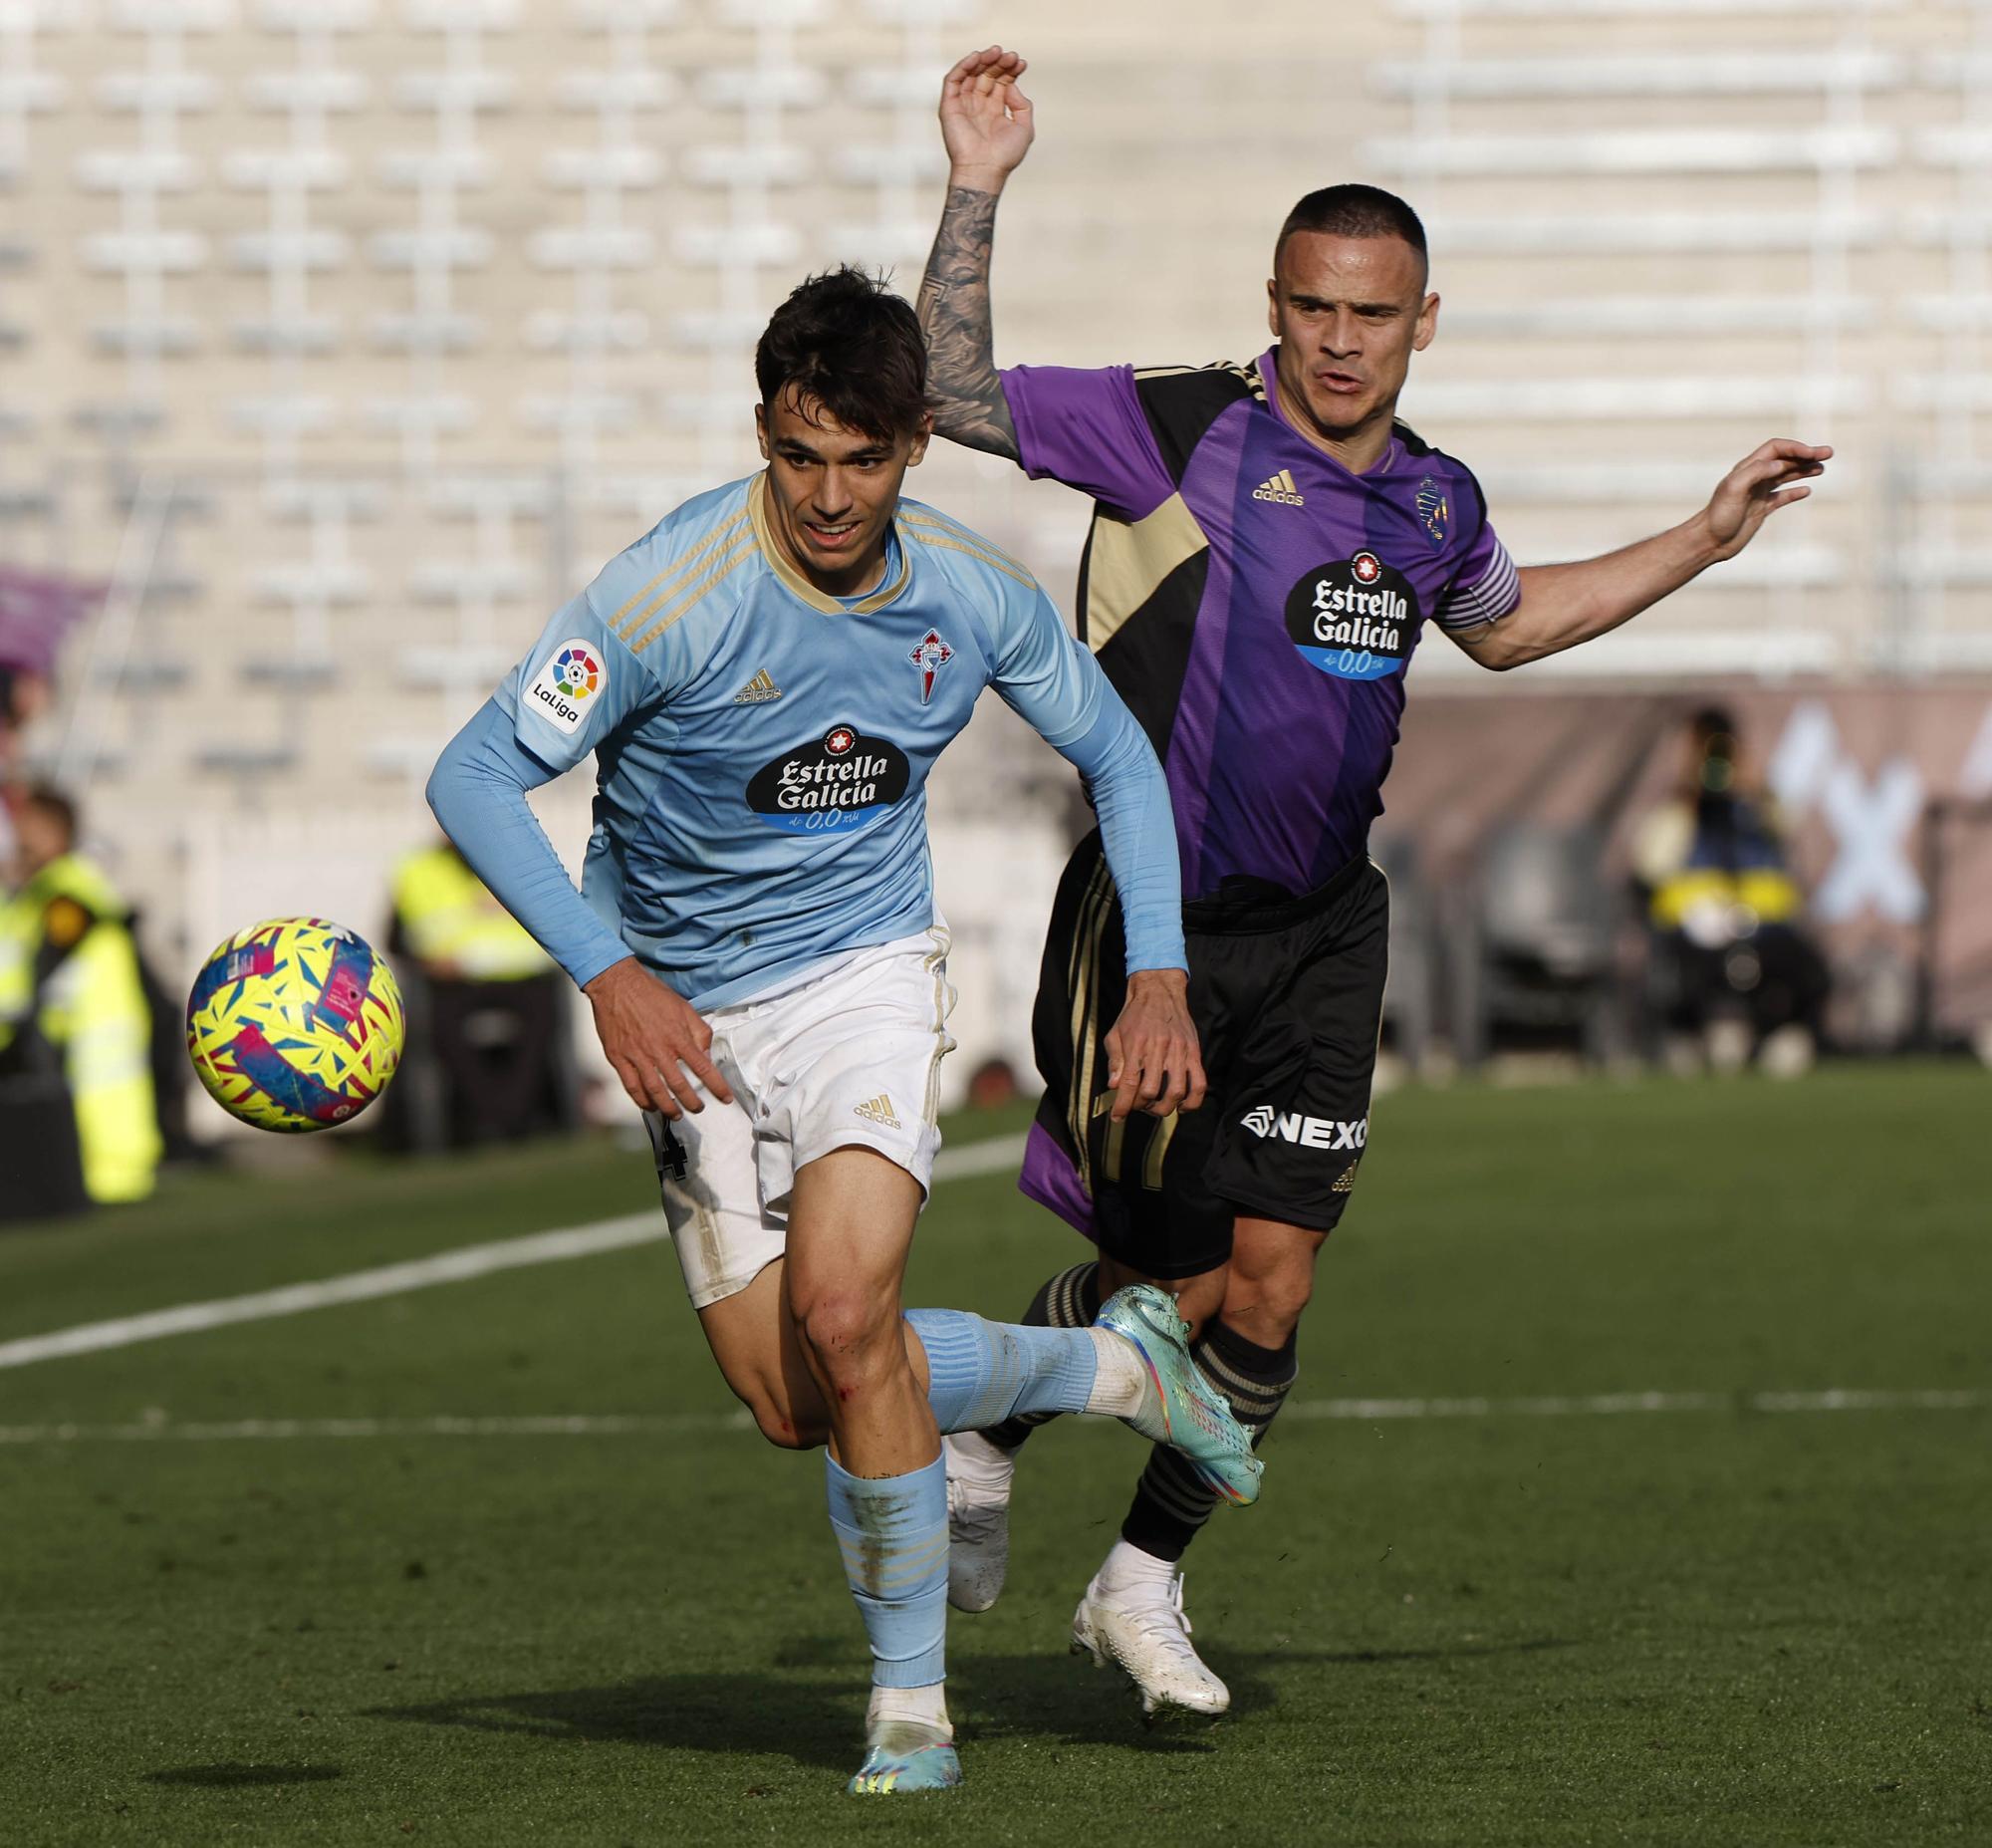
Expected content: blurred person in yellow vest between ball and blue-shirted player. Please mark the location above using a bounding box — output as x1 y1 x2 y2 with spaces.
386 841 580 1149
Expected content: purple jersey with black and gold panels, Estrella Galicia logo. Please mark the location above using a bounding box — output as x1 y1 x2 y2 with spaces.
1002 349 1522 899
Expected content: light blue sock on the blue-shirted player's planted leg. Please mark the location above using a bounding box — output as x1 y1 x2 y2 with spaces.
823 1452 948 1687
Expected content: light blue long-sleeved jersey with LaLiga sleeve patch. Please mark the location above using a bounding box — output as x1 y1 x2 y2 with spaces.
430 476 1183 1007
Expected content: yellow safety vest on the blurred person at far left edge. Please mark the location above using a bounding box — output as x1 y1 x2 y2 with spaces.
0 855 163 1200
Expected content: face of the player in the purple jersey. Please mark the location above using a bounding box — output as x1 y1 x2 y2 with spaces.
1265 231 1438 474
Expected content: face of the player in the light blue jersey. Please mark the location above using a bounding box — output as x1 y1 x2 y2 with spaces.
755 387 932 598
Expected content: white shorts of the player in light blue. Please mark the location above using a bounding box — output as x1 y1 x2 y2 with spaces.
643 924 954 1308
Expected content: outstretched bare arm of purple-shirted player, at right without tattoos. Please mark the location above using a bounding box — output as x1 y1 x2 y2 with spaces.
1446 436 1833 669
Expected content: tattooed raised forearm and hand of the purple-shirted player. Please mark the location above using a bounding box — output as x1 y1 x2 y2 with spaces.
920 46 1032 462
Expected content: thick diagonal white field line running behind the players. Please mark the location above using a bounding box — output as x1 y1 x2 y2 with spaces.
0 1135 1024 1368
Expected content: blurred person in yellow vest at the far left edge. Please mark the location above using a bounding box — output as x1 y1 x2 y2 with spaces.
0 783 163 1216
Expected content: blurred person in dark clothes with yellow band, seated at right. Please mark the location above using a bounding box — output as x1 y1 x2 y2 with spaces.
1633 707 1833 1075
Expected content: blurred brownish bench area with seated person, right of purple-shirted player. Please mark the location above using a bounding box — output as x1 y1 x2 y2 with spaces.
1372 679 1992 1073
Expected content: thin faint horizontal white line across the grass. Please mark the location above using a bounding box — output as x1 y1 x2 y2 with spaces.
0 1386 1992 1446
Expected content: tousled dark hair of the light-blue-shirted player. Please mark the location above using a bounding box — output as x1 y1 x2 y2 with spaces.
753 263 926 442
